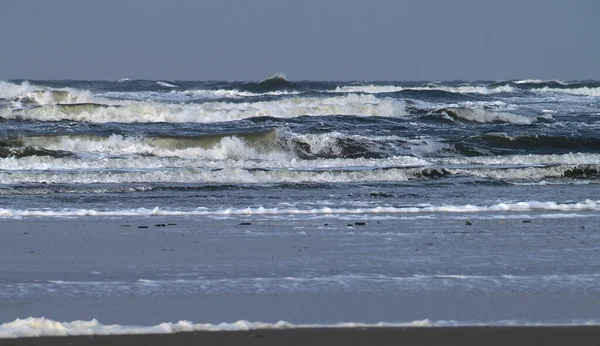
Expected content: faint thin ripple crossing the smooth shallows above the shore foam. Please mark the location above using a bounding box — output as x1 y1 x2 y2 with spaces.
10 274 600 297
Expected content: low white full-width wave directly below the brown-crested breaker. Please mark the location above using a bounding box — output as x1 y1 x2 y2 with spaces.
0 164 600 184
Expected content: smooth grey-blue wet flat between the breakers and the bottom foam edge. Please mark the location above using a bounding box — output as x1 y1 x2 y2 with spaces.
0 215 600 330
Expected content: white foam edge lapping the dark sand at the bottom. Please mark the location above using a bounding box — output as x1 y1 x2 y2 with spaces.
0 317 432 338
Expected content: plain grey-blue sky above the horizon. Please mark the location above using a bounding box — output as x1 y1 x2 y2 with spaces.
0 0 600 81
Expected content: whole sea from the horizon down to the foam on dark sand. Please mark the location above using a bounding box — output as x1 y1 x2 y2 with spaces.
0 76 600 337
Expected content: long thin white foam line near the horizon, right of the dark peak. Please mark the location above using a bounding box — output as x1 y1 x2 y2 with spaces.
329 85 515 95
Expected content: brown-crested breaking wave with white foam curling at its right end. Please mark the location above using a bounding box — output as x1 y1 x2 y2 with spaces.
0 129 418 160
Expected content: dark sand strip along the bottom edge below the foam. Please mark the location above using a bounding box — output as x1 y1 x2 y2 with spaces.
0 326 600 346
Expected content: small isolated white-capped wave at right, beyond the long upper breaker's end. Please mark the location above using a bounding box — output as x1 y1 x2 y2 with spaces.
434 108 537 125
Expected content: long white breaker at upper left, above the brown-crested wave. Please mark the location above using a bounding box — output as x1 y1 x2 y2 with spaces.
0 94 406 123
